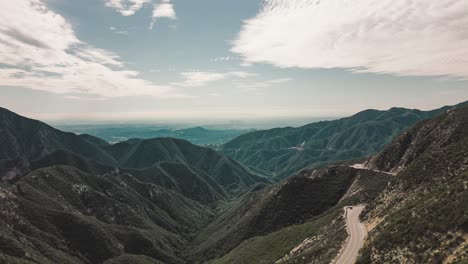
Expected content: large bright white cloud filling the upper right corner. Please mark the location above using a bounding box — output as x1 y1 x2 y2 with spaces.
232 0 468 79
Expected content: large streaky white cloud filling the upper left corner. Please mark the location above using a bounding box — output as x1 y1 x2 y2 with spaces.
0 0 172 97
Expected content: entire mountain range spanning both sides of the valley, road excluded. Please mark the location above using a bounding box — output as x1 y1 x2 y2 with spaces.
0 104 468 264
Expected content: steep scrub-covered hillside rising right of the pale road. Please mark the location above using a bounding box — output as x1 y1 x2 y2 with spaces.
360 104 468 263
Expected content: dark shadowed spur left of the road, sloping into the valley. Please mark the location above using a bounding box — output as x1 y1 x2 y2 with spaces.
188 166 390 263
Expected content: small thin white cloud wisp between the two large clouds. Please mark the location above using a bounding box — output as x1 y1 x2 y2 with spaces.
172 71 256 87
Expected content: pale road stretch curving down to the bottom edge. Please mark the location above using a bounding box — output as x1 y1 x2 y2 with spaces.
335 206 367 264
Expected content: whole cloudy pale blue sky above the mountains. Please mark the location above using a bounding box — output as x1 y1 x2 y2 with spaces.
0 0 468 122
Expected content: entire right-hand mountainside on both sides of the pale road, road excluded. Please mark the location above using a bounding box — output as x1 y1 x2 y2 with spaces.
189 103 468 264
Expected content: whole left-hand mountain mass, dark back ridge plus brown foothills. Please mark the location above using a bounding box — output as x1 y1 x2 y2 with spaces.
0 109 269 264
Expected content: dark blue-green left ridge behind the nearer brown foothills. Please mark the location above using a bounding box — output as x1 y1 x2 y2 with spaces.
0 108 269 203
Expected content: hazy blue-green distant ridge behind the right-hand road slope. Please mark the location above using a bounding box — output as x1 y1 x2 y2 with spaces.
220 104 462 179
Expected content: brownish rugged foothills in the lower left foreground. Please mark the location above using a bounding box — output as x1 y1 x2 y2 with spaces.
0 166 211 263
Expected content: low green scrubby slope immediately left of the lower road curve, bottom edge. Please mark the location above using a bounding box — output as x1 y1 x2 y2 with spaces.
209 207 346 264
